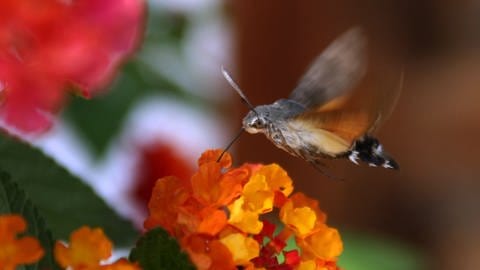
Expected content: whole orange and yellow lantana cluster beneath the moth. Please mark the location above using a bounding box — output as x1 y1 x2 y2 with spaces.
144 150 343 270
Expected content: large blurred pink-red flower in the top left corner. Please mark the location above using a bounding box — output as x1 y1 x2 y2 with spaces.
0 0 144 132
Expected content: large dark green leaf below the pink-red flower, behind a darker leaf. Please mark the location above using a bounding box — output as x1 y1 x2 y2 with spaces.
0 135 137 245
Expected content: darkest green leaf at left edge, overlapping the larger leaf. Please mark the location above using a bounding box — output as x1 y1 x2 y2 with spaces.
0 172 60 270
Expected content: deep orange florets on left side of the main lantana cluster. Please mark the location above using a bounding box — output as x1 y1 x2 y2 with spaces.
144 150 250 237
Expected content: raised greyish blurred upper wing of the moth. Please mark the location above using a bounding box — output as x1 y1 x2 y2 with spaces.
289 28 367 110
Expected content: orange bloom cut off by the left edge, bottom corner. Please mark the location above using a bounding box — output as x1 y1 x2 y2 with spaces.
0 215 44 270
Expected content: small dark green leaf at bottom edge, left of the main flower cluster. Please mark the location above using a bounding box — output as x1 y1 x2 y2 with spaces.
129 228 195 270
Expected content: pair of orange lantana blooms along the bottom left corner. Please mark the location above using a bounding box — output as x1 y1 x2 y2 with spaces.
0 215 140 270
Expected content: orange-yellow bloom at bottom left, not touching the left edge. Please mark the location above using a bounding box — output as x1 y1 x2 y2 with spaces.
54 226 112 269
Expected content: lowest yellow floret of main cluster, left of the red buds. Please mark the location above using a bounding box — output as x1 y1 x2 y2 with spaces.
220 233 260 265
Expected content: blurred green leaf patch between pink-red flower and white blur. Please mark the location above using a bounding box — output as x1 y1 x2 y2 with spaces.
65 60 184 155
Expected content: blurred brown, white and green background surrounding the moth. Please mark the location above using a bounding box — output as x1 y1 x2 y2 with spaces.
34 0 480 270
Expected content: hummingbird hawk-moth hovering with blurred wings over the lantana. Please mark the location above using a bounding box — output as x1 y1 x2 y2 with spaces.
222 28 403 171
